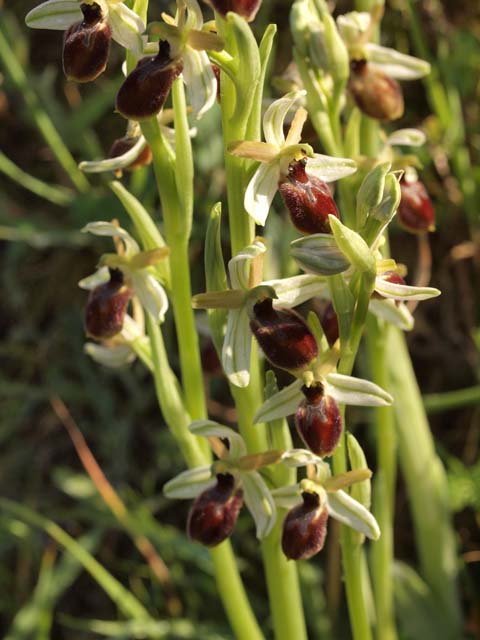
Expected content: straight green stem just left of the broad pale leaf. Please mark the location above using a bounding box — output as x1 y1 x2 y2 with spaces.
367 315 397 640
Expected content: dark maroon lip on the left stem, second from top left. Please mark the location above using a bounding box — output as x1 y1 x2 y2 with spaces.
115 41 183 120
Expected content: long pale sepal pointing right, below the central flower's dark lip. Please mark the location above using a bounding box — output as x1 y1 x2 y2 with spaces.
325 373 393 407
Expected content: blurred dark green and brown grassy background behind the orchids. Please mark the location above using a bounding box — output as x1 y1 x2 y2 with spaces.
0 0 480 640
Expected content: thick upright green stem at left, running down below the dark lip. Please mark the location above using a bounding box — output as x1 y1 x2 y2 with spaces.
142 114 207 420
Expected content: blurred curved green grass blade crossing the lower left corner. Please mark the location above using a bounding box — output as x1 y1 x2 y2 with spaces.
0 498 151 620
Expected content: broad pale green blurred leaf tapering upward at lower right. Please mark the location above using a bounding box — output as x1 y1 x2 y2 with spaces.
386 328 461 640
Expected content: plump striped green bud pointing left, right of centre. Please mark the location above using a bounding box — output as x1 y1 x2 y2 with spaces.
290 233 350 276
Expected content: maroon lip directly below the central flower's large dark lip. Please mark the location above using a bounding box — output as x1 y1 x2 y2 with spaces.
295 385 342 457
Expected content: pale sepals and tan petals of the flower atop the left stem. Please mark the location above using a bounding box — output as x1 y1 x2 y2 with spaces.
149 0 224 119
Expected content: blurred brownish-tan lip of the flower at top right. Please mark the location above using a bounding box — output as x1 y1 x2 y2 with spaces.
348 60 405 121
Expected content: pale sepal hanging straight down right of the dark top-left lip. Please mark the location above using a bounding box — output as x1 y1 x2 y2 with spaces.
183 47 217 120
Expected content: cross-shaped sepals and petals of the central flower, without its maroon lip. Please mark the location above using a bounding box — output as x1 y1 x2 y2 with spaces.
193 240 327 387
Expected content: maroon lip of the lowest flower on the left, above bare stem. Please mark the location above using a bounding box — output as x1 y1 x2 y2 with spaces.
187 473 243 547
